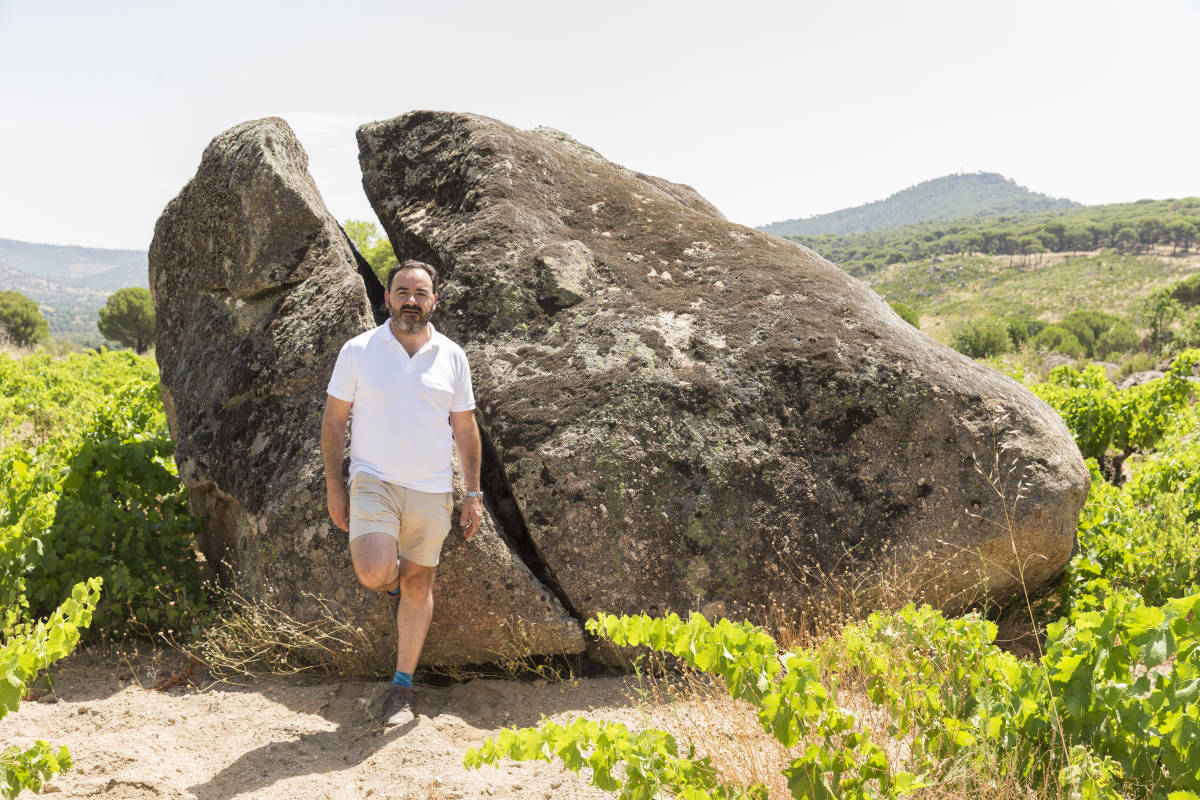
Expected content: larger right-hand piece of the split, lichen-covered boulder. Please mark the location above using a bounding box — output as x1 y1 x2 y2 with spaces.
358 112 1088 615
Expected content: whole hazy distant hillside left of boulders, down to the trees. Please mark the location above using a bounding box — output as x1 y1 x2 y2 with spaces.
0 239 149 344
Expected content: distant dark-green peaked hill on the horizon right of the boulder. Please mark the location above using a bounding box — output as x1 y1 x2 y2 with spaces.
760 173 1079 236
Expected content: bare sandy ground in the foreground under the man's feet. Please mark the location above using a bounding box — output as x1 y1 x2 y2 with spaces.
0 654 644 800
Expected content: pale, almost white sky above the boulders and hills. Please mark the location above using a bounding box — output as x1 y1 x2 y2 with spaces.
0 0 1200 249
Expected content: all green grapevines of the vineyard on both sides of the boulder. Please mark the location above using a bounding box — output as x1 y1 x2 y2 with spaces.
0 350 1200 800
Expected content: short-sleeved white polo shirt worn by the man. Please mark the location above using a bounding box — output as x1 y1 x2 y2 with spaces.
328 323 475 492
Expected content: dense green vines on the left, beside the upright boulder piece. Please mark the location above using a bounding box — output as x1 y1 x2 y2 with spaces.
0 351 210 636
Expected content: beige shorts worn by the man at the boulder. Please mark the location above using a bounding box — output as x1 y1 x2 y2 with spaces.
350 473 454 566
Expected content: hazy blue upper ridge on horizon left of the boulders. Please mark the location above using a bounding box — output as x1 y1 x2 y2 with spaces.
0 239 149 293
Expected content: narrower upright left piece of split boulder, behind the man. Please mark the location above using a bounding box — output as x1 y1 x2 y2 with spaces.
150 119 583 669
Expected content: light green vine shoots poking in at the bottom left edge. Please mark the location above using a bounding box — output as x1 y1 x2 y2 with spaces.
0 578 102 800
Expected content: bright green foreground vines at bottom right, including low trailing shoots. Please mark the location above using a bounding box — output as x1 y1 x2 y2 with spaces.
464 594 1200 800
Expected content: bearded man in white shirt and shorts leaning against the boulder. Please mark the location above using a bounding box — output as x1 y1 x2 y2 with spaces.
320 260 484 724
